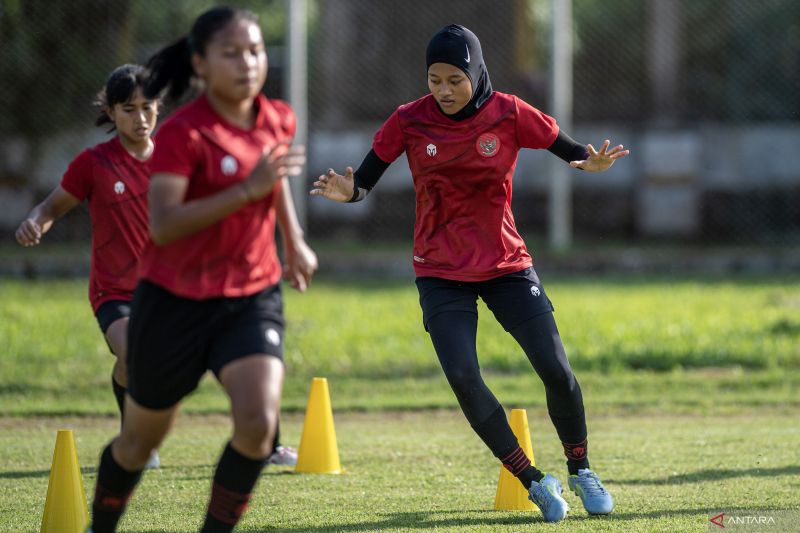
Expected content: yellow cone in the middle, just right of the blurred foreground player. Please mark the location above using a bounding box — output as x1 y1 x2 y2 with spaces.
294 378 342 474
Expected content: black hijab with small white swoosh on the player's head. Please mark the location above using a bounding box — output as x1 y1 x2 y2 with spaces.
425 24 492 120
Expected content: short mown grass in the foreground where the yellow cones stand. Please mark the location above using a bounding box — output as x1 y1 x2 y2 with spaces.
0 408 800 533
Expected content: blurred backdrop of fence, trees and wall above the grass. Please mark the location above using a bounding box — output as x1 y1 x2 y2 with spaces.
0 0 800 277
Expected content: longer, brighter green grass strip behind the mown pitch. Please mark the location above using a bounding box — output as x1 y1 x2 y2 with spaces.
0 278 800 416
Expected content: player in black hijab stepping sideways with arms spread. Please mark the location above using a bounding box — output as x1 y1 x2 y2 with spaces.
311 25 628 522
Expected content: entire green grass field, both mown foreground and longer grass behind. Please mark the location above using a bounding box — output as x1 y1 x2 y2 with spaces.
0 278 800 533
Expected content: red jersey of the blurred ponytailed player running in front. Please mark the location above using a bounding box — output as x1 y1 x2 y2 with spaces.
141 95 295 300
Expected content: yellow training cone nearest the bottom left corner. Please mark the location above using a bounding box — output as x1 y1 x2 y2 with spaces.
40 429 89 533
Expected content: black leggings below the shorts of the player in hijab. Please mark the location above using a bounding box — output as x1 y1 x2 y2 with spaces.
428 311 586 457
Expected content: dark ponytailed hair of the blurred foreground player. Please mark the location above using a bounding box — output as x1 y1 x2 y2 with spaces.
144 6 258 101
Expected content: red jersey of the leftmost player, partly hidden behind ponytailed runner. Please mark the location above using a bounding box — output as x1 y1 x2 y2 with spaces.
61 137 150 311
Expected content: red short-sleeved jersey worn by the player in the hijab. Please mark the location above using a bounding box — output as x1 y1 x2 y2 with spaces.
372 92 558 281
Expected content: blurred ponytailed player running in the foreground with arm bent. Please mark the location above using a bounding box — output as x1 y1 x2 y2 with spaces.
86 7 316 533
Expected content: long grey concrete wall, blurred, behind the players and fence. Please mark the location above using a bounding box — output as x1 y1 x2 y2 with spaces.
0 123 800 240
